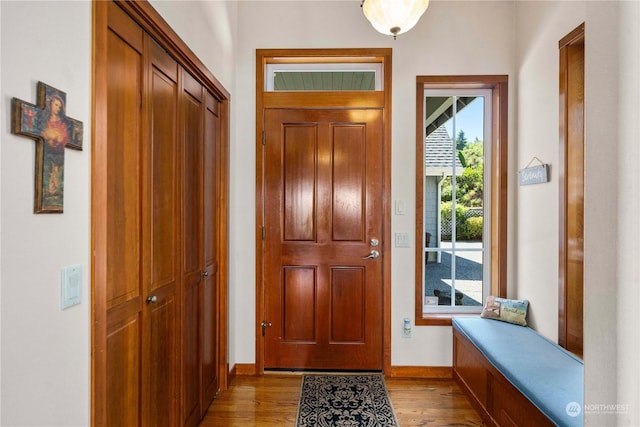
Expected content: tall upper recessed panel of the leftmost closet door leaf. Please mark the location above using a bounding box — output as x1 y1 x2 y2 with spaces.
105 10 142 308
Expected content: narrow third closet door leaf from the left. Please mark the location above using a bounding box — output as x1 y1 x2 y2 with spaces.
181 71 205 426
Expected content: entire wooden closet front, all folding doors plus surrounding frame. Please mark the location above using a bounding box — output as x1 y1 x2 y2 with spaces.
91 1 228 427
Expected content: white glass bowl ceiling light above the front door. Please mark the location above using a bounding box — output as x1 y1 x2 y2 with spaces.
360 0 429 39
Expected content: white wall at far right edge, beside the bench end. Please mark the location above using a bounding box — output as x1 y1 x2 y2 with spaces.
584 2 640 425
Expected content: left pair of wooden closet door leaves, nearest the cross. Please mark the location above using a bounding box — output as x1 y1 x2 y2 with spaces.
105 3 179 426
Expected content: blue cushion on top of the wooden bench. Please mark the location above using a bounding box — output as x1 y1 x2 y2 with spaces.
452 317 584 426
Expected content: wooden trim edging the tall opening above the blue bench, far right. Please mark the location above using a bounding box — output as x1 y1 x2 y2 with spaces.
558 22 585 348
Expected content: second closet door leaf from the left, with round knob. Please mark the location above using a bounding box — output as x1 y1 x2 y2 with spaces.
142 41 180 427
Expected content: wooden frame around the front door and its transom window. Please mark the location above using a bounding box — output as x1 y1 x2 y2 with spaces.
255 48 392 375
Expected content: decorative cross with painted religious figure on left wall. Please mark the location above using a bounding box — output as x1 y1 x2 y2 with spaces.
11 82 82 213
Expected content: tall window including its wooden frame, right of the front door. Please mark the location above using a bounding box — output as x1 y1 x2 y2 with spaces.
416 76 506 324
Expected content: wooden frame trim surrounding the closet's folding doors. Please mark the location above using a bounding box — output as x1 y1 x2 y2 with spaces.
90 0 231 426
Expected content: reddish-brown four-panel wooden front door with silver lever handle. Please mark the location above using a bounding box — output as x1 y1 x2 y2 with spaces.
263 109 384 370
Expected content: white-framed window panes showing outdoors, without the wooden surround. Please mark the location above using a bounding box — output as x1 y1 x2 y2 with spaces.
420 89 491 312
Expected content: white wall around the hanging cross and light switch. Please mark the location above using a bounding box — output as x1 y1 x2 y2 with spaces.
0 1 91 426
